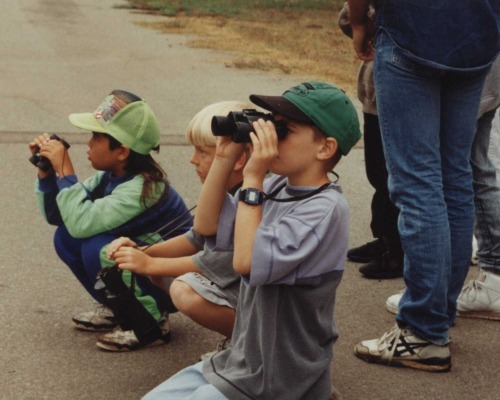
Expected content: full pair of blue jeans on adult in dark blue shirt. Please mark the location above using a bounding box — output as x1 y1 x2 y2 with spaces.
374 30 487 345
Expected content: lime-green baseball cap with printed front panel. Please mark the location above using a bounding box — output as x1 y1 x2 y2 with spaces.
68 90 160 155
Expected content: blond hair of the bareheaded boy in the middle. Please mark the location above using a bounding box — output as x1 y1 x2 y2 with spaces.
186 101 263 147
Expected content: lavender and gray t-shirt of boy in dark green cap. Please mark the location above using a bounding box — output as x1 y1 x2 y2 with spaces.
203 176 349 400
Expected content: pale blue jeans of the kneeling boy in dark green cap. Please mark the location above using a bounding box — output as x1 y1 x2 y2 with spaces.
143 362 228 400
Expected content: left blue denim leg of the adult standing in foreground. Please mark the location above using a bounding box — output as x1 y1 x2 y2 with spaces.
375 34 451 344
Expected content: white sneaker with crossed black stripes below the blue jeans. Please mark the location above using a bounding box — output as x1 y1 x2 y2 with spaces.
354 324 451 372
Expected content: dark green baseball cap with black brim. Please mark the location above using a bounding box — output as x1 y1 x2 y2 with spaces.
250 81 361 155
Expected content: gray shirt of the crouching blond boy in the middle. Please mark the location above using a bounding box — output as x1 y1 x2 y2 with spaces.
184 229 240 307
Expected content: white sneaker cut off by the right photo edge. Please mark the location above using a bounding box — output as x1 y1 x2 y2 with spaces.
457 269 500 321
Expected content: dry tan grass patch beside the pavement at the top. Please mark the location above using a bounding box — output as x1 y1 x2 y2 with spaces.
135 11 359 95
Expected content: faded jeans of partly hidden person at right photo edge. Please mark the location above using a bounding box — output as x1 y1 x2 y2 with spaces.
471 110 500 274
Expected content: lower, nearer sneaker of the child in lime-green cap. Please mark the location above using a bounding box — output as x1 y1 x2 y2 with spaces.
96 314 170 352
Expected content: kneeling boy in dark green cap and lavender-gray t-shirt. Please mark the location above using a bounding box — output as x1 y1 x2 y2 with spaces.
145 82 361 400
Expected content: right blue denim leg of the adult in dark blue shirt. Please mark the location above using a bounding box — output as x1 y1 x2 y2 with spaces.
441 72 486 326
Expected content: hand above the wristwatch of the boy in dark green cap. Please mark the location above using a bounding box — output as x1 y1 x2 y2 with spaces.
243 119 278 181
